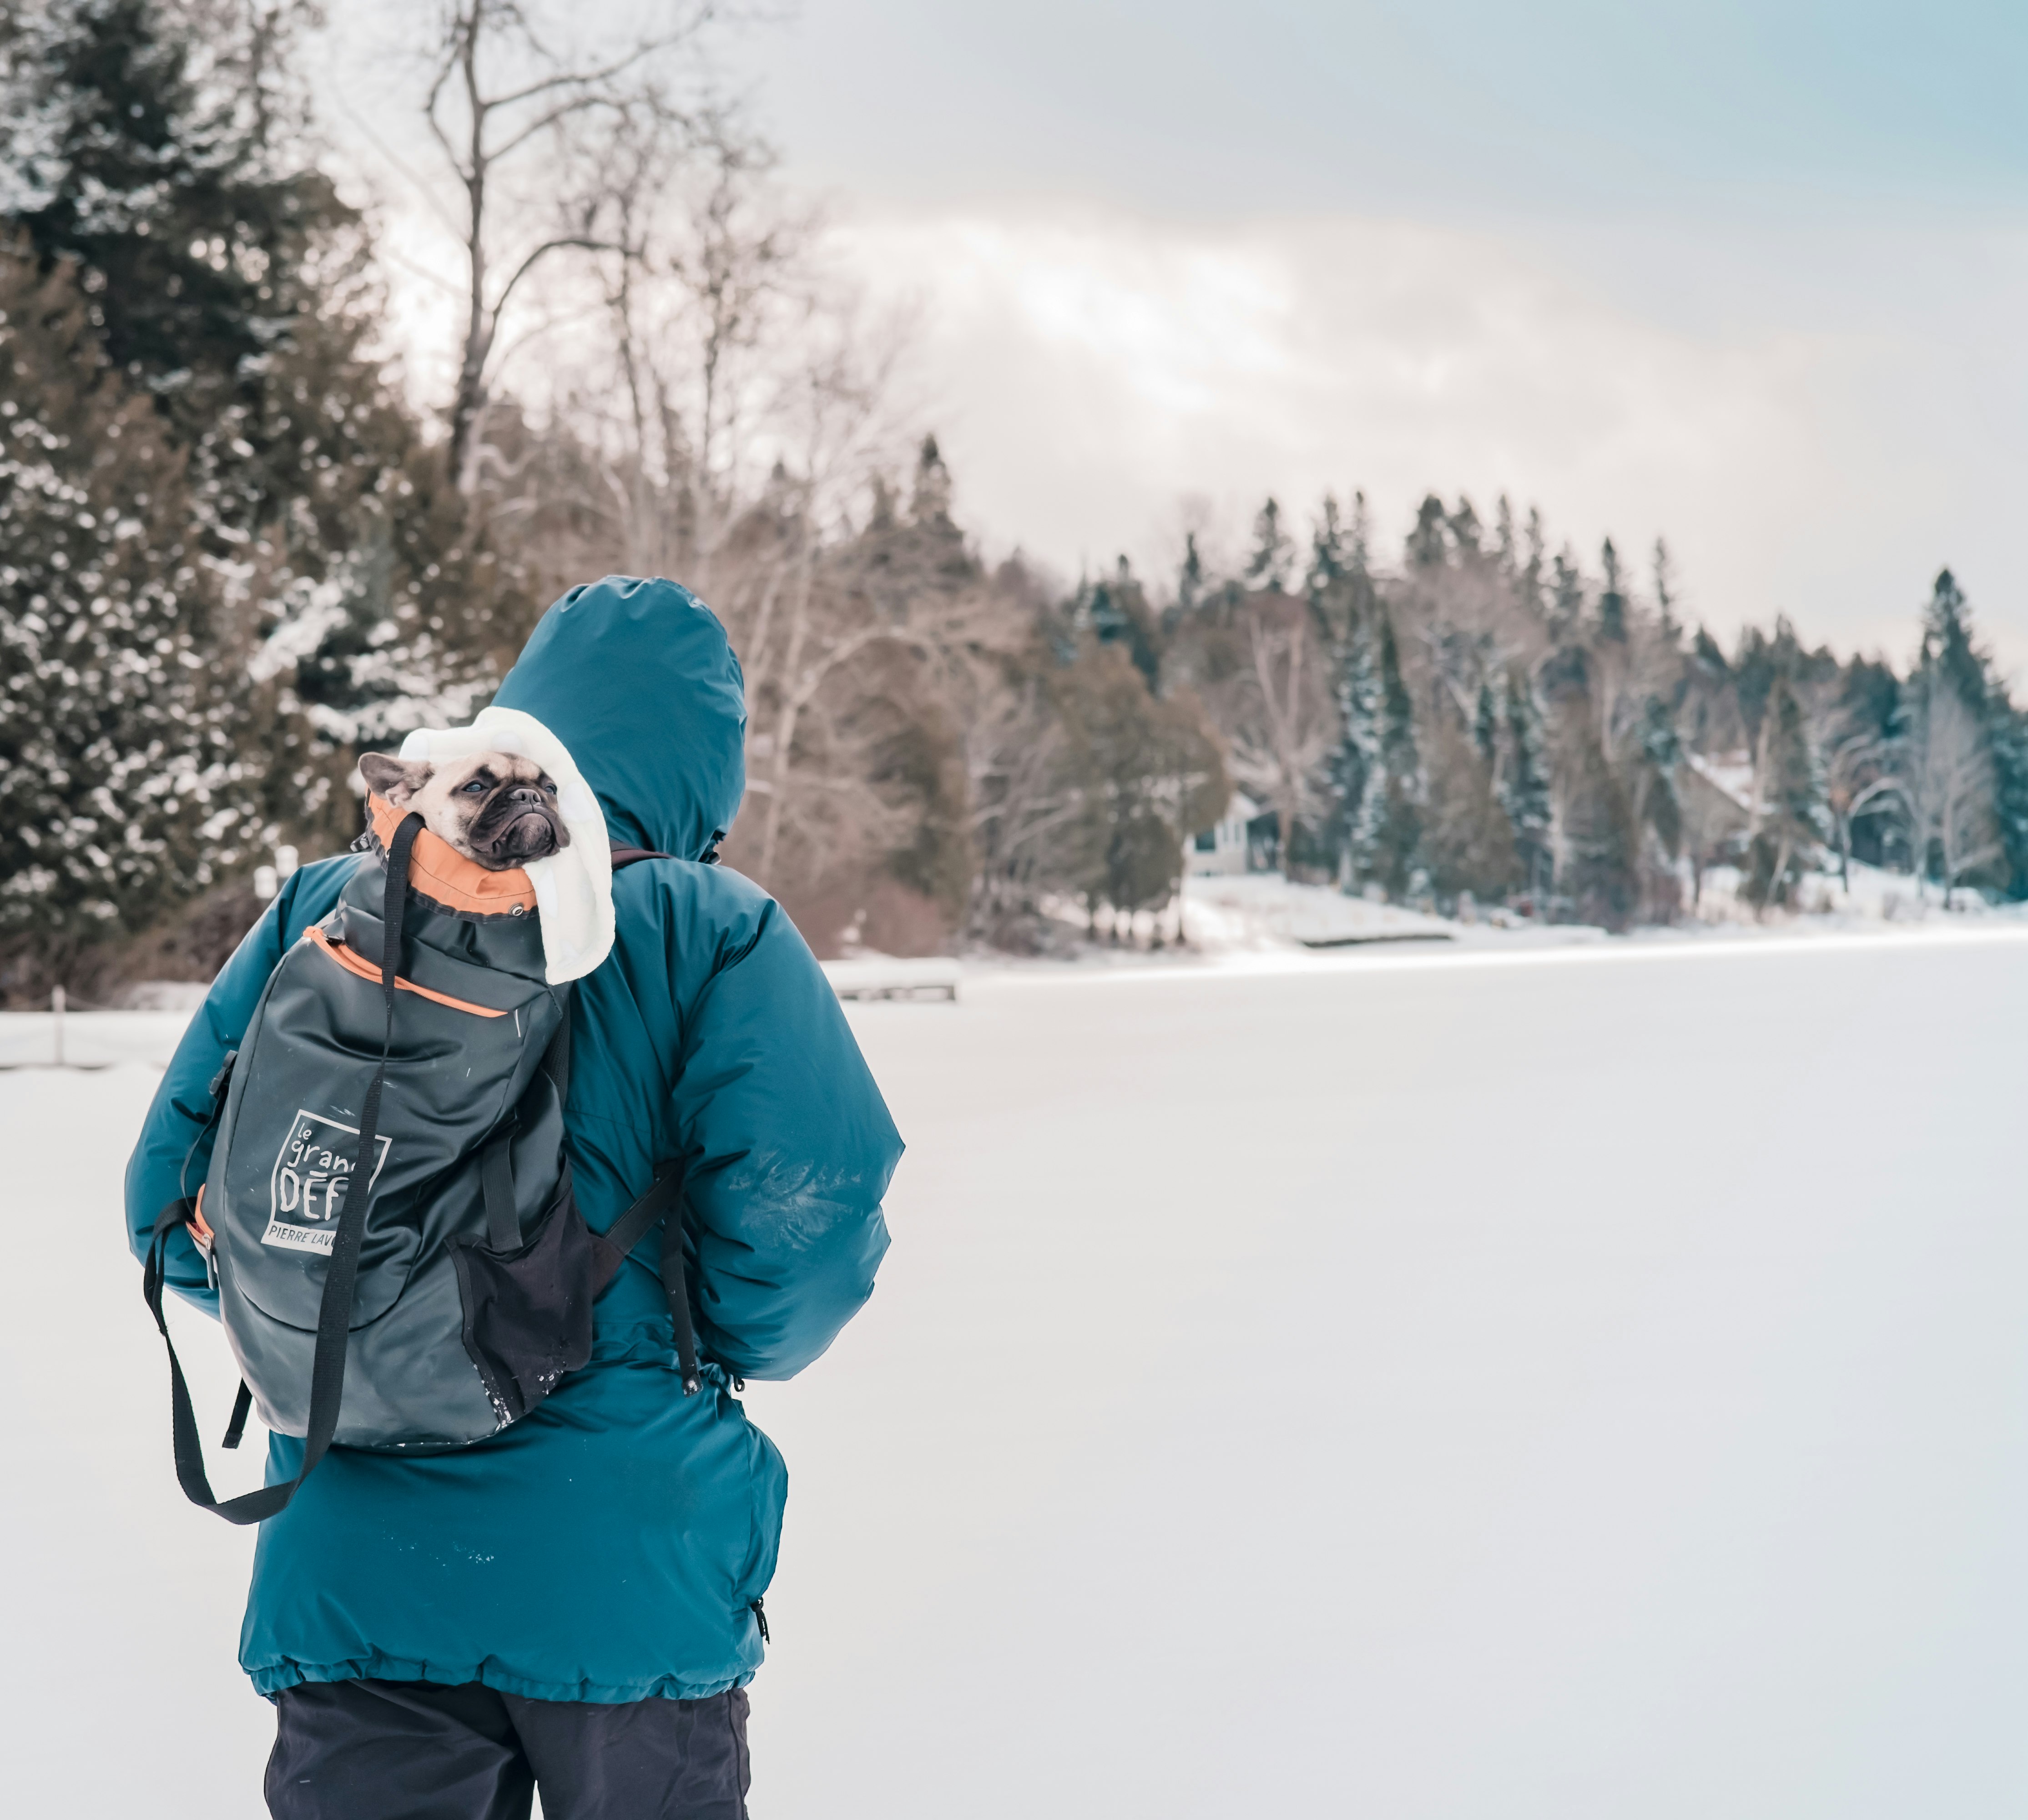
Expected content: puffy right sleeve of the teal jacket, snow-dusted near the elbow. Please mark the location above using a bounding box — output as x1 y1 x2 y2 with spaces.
671 893 903 1378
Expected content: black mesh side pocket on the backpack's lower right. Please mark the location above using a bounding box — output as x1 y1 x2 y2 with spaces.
450 1177 596 1428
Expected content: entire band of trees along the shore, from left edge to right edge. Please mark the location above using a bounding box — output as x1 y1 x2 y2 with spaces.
0 0 2028 996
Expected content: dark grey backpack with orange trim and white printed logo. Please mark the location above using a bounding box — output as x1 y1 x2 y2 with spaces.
142 805 700 1524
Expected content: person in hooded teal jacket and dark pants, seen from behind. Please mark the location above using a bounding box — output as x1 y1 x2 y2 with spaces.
126 576 900 1820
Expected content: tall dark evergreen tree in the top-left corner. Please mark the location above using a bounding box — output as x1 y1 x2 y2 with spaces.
0 0 353 534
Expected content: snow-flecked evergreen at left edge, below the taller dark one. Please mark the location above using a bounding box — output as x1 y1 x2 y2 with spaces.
0 253 267 957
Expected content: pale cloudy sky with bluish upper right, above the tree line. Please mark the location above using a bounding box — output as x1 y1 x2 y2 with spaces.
320 0 2028 670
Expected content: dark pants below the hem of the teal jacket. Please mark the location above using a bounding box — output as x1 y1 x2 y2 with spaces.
267 1680 752 1820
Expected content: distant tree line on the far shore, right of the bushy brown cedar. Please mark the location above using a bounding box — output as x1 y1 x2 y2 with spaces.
1160 495 2028 929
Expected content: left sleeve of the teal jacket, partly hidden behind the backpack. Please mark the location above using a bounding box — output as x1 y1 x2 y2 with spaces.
126 856 359 1315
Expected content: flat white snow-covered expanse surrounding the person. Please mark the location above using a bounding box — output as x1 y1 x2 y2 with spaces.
0 927 2028 1820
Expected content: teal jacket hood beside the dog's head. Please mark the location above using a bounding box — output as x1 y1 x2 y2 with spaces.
493 574 747 860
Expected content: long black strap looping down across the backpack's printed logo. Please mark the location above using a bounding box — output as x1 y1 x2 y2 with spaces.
142 816 422 1524
